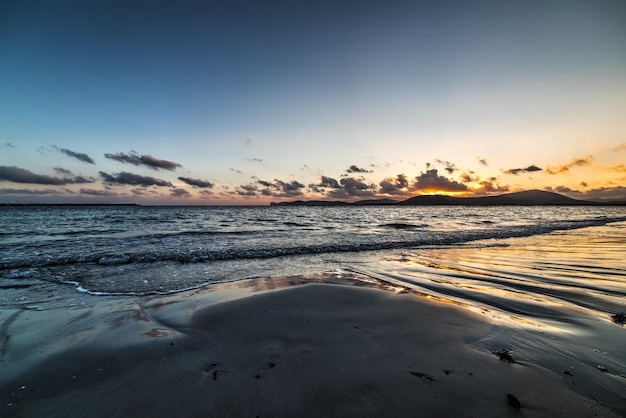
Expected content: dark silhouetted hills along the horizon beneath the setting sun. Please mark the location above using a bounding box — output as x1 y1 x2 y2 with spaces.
272 190 625 206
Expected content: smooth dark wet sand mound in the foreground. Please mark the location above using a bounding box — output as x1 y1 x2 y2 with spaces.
0 280 626 417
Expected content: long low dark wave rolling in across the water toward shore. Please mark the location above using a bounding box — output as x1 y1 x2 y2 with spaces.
0 217 626 270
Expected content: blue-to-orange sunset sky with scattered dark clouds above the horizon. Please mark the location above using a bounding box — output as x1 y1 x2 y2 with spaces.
0 0 626 205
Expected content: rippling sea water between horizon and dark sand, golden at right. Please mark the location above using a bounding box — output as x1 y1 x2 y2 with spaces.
0 206 626 322
